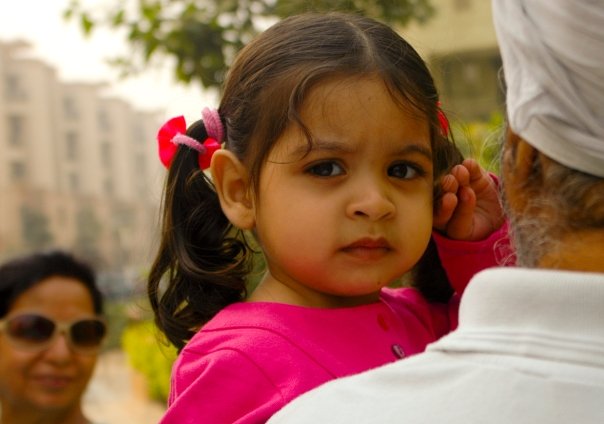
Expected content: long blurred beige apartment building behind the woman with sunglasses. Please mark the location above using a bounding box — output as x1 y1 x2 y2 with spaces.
0 38 164 280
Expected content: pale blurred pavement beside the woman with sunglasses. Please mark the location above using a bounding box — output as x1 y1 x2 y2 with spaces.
83 350 165 424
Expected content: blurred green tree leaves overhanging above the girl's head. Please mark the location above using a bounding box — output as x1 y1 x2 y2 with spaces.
64 0 434 88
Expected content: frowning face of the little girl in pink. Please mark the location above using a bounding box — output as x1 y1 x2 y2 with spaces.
252 77 433 307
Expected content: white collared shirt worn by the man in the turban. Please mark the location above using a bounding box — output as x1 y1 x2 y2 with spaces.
269 268 604 424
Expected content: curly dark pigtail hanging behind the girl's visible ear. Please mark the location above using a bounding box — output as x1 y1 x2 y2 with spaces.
147 121 251 350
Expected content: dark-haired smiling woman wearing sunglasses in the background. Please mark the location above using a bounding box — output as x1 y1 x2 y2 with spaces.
0 251 106 424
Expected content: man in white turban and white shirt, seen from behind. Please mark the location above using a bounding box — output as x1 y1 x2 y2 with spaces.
269 0 604 424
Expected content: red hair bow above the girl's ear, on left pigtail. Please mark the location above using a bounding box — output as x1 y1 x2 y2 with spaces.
157 116 220 169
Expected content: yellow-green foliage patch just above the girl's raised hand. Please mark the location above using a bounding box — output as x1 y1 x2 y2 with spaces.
451 112 504 175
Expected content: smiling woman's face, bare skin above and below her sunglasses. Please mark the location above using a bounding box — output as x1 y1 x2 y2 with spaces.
0 276 97 411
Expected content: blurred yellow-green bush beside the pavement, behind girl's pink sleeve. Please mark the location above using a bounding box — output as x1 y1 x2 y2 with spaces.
122 321 176 403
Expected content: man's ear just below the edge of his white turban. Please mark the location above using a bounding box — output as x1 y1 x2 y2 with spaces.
502 129 540 211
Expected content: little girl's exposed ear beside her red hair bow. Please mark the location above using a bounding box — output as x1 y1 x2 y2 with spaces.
210 149 255 230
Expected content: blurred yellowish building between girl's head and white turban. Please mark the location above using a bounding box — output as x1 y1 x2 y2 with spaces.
401 0 504 121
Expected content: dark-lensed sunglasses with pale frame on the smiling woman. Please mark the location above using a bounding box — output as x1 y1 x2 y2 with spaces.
0 313 107 353
